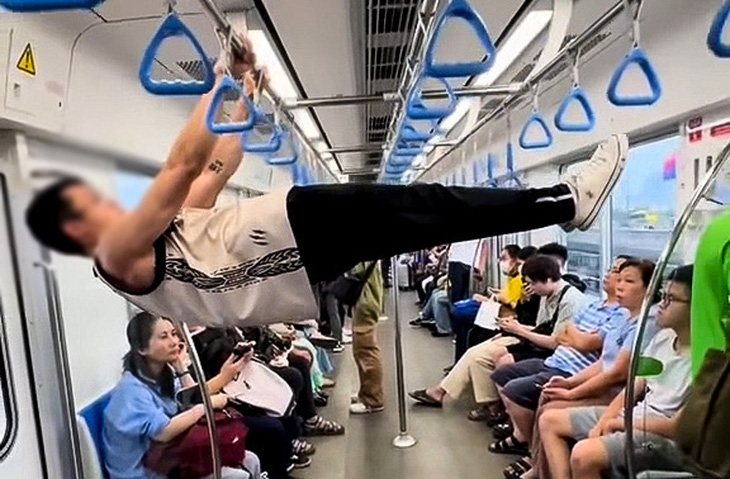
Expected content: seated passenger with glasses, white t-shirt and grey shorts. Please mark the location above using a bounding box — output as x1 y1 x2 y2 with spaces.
540 266 693 479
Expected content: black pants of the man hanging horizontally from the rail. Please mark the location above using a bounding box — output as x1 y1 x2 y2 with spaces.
287 184 575 283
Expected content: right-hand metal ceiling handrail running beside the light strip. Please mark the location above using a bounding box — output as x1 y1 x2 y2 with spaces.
416 0 625 180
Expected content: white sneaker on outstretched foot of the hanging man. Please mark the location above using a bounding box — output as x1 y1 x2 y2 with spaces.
561 134 629 232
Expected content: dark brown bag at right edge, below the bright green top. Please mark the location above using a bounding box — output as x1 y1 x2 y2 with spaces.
676 344 730 479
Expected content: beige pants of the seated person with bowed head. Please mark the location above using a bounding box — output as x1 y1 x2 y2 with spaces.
440 335 520 404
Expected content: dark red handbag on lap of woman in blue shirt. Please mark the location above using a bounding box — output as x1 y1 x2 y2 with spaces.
143 408 248 479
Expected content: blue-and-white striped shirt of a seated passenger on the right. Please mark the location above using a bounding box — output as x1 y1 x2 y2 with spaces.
545 301 626 374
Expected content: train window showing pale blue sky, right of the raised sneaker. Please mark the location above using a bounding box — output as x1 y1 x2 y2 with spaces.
612 136 680 261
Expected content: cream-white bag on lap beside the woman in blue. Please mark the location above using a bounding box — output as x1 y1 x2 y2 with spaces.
223 361 293 416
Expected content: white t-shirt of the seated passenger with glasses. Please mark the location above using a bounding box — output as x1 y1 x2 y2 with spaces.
634 329 692 418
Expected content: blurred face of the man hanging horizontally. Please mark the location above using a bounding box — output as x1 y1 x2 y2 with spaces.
63 185 124 248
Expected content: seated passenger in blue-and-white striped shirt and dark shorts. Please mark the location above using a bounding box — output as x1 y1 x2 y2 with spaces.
489 262 636 456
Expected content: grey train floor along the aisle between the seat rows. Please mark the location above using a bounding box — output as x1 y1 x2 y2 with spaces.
292 290 516 479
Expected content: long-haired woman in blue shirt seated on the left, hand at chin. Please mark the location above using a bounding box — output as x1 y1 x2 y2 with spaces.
103 313 258 479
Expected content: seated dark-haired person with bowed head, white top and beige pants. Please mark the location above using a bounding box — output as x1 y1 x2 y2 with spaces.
409 255 584 424
